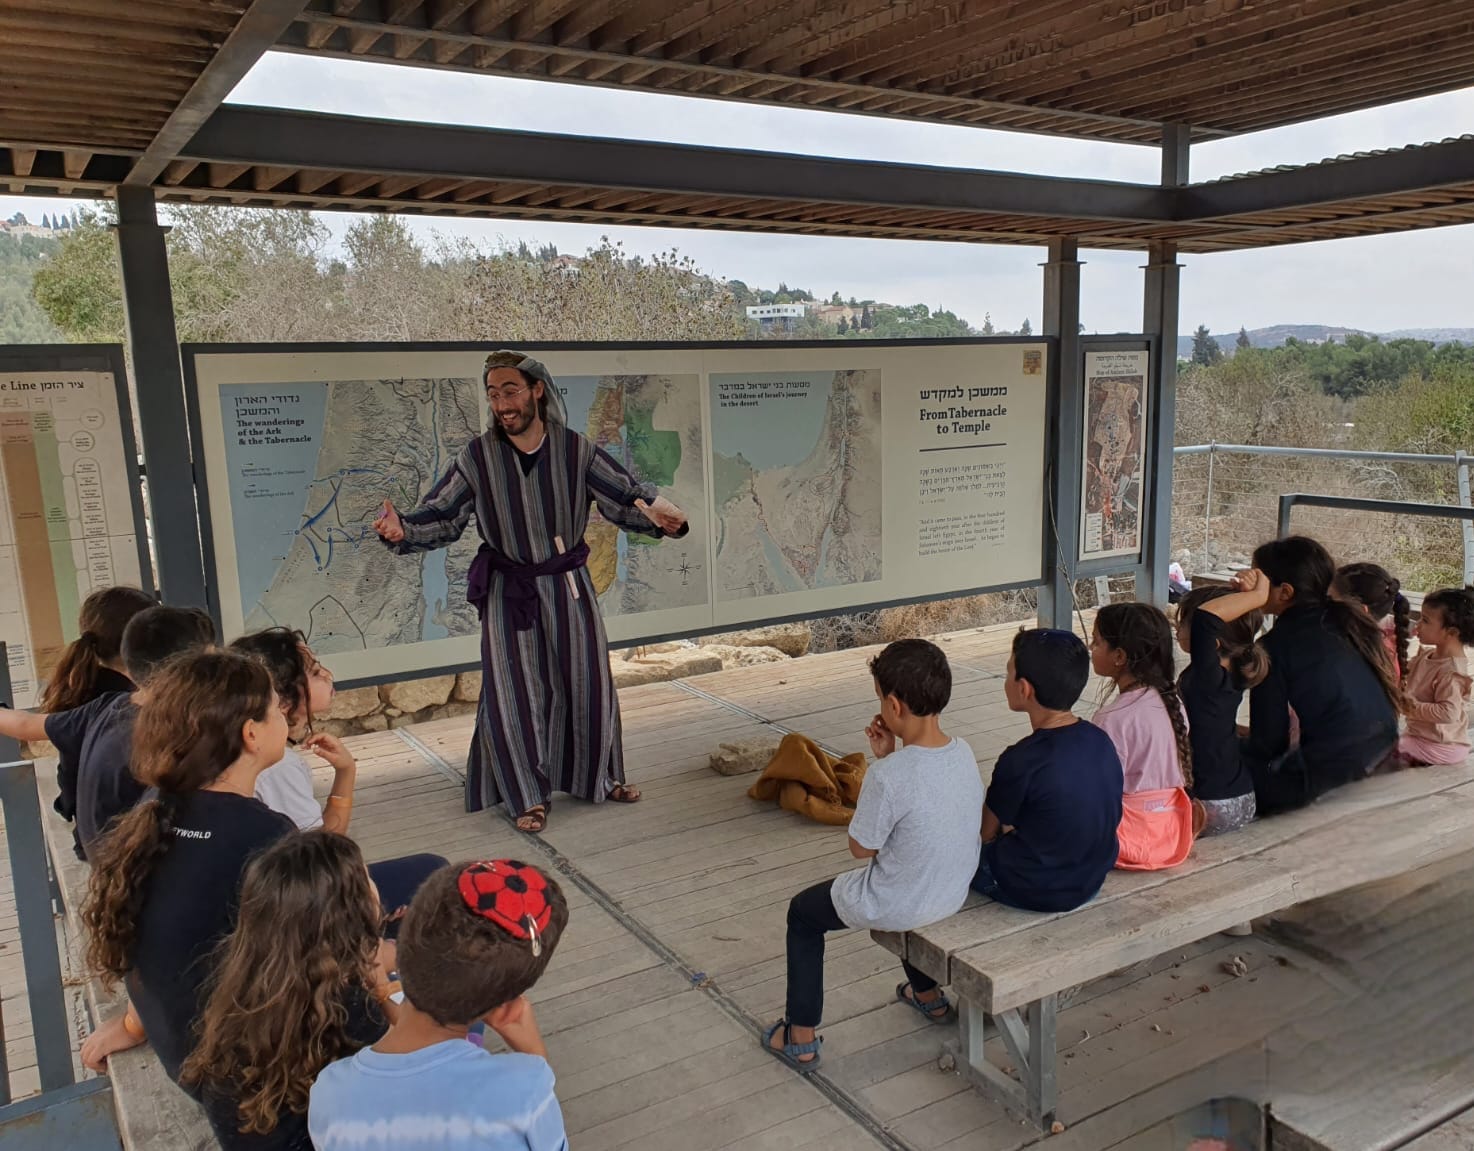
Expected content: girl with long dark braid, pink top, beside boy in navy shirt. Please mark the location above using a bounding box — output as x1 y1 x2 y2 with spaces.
1091 603 1194 871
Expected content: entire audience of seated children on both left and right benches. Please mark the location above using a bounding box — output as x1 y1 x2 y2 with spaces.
0 538 1474 1151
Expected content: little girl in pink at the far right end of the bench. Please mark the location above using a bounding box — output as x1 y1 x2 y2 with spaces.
1397 588 1474 766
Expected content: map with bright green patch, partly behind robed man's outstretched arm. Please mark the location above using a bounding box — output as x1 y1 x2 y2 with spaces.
559 373 708 619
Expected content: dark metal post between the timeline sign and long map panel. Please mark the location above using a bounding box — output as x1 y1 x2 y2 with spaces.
118 187 206 607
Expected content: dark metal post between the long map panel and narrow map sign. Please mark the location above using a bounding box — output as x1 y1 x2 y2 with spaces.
1039 239 1085 628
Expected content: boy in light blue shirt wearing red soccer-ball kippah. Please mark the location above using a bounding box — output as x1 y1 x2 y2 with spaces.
307 859 567 1151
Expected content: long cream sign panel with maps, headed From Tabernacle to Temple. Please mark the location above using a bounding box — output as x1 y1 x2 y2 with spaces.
186 342 1048 679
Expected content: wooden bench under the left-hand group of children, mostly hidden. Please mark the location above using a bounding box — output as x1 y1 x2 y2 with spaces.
35 760 220 1151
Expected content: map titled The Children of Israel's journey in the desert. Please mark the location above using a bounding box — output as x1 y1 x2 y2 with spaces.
710 370 883 600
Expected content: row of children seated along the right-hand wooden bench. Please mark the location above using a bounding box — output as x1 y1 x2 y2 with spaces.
764 536 1474 1071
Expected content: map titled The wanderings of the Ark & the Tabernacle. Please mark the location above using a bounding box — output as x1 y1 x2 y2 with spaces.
220 379 481 656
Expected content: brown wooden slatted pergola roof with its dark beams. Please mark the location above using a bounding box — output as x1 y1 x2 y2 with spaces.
0 0 1474 251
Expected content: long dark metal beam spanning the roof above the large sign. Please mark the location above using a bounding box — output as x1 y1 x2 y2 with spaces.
180 105 1172 223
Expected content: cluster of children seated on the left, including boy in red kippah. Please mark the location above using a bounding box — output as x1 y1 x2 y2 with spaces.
0 588 567 1151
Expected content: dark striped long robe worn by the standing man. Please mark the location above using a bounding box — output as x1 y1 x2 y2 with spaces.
391 423 663 815
